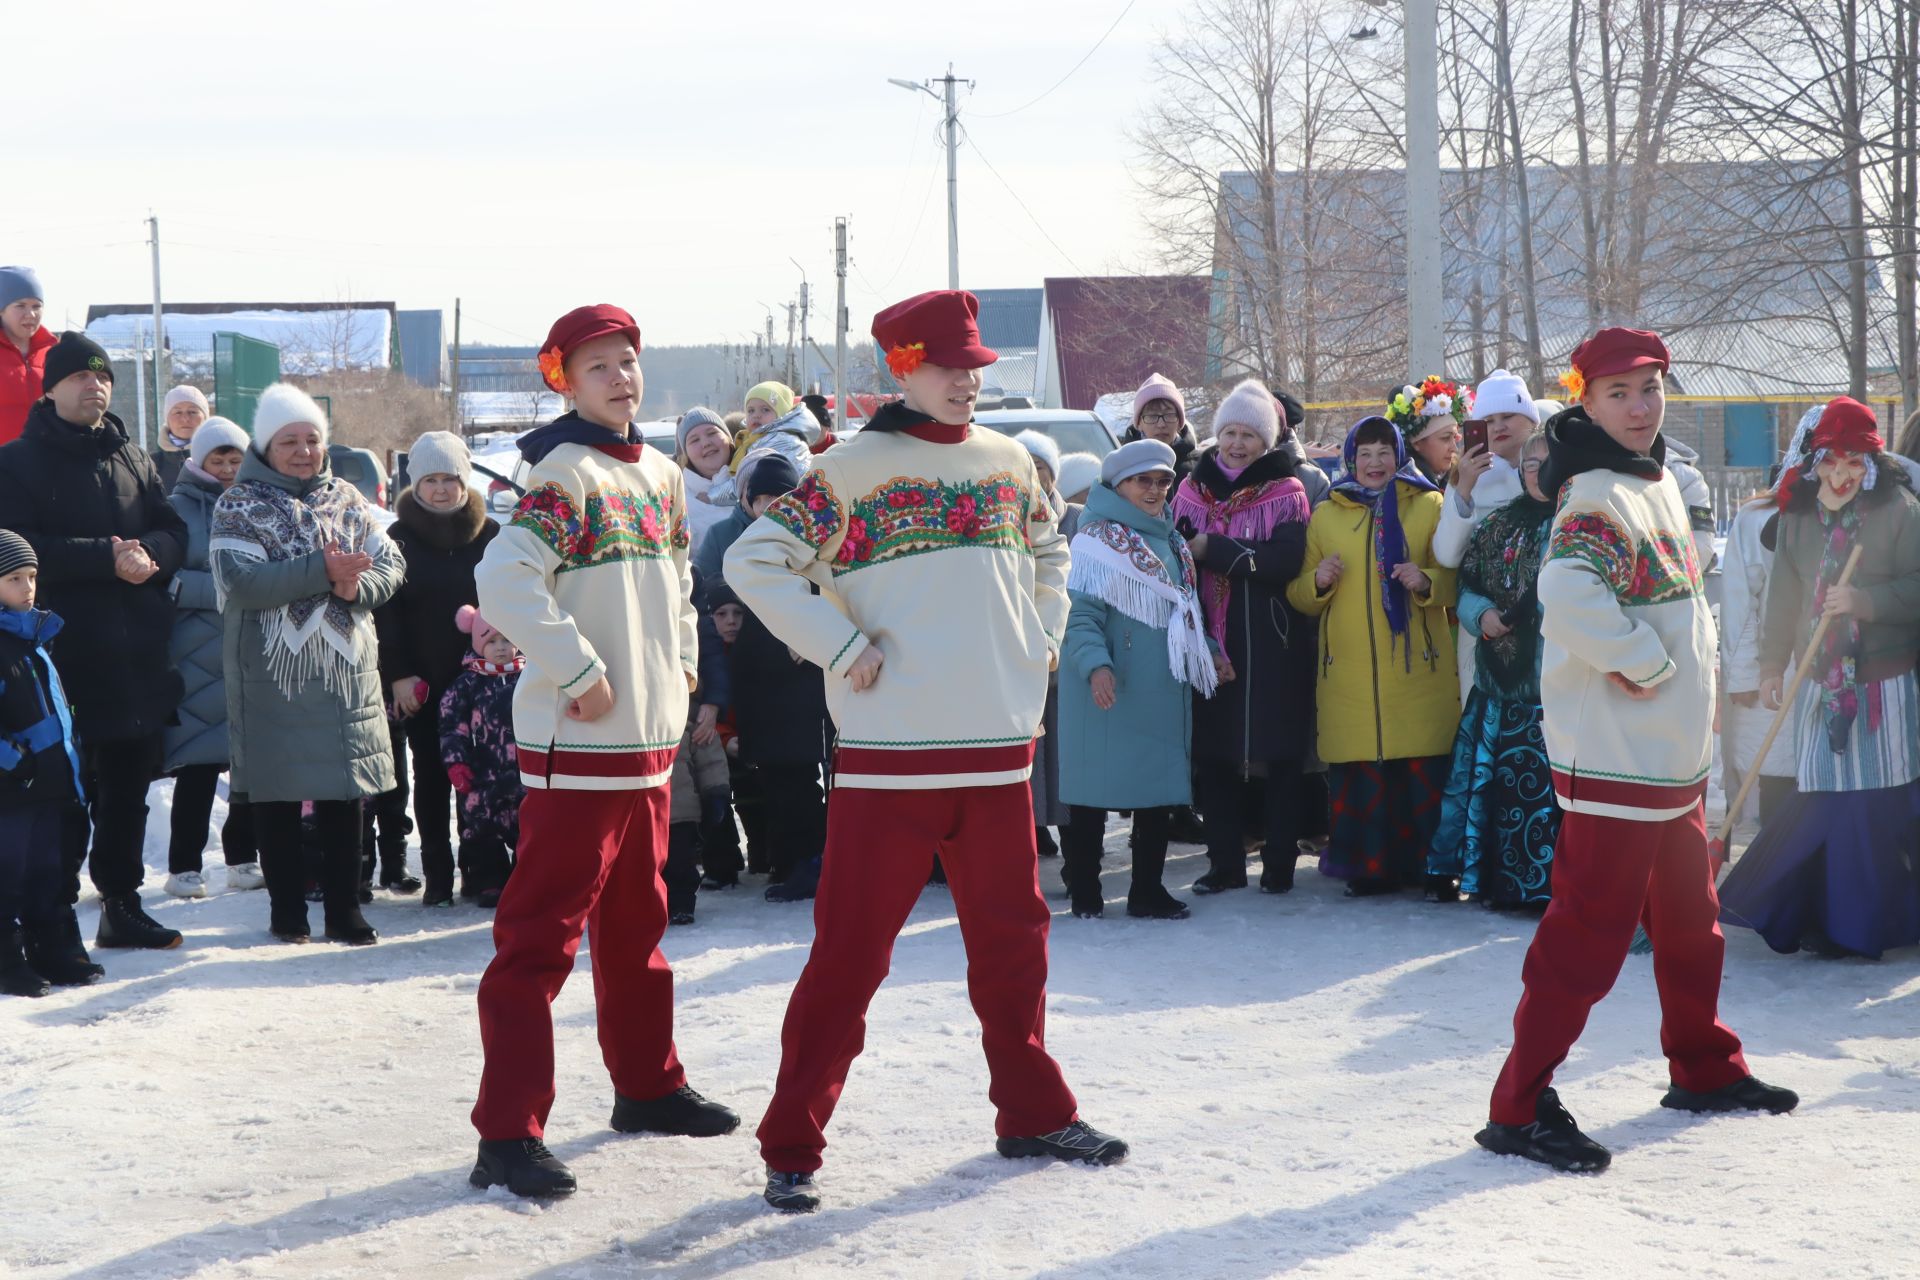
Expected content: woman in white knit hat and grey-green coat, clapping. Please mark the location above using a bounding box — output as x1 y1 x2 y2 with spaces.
209 382 407 944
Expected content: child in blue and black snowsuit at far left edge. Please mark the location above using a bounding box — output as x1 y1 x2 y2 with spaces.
0 530 106 996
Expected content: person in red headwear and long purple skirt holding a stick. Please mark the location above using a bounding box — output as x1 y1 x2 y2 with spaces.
1720 395 1920 960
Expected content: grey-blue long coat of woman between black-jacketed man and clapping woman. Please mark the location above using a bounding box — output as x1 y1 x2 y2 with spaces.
165 470 228 773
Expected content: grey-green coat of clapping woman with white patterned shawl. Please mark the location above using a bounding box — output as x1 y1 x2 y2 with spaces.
213 449 407 804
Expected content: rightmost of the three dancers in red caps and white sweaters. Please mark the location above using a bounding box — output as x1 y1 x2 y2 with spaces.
1476 328 1799 1173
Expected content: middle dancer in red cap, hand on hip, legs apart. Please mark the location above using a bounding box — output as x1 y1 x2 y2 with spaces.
726 290 1127 1211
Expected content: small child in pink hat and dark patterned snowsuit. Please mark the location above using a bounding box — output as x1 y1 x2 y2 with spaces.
440 604 526 910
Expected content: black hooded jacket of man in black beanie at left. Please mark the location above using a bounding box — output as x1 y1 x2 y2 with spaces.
0 399 186 743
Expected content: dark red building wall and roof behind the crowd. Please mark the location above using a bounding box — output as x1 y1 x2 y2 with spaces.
1046 276 1212 409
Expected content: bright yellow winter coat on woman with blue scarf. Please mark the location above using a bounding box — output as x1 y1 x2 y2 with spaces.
1286 480 1459 764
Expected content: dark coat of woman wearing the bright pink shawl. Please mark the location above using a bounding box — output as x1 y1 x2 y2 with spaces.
1187 449 1319 766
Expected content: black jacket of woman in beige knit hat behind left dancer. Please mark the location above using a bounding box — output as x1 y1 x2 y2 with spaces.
372 487 499 706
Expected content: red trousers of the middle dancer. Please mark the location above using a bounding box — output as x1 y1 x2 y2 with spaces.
760 783 1075 1171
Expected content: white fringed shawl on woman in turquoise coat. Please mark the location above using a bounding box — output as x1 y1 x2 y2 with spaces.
1068 505 1219 697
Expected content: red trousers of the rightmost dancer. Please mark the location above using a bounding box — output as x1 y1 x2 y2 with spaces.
1492 806 1747 1125
